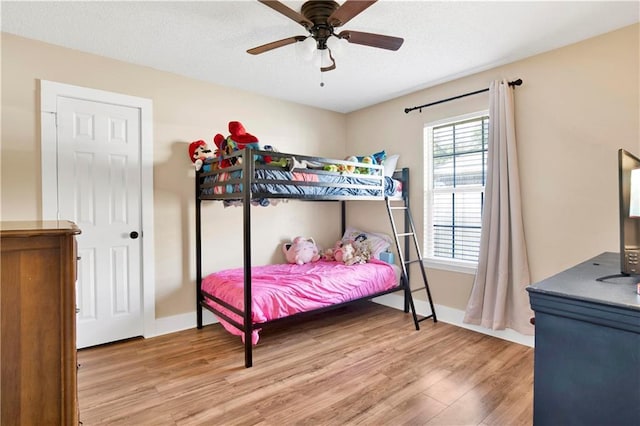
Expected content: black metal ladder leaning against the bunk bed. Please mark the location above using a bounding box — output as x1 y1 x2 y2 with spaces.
386 197 438 330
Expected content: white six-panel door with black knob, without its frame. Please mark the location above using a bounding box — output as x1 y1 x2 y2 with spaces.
57 97 143 348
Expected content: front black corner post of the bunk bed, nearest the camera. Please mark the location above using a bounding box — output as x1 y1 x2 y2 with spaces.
242 148 254 368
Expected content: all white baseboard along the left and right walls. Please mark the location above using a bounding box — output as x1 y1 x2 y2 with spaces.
150 294 534 347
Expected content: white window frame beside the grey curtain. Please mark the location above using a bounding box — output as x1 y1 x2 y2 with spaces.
422 109 489 275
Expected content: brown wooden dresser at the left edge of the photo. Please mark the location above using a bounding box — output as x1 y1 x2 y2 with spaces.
0 221 80 425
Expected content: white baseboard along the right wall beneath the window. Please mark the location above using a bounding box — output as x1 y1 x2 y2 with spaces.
373 294 535 348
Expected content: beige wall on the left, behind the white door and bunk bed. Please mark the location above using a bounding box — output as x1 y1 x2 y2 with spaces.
0 33 346 317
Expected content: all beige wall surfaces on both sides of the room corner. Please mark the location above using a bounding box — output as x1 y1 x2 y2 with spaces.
0 25 640 317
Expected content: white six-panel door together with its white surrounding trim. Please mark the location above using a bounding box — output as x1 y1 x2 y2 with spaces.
40 80 156 348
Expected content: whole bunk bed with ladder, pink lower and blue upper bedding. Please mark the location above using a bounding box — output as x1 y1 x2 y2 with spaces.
195 148 436 367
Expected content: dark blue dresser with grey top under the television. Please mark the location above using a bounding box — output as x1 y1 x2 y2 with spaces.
527 253 640 426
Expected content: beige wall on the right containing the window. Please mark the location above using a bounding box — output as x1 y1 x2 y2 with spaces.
347 24 640 309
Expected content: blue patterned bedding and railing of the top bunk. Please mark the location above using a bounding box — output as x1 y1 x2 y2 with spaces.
196 149 402 200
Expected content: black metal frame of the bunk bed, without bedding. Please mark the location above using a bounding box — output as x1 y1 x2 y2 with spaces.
195 148 419 368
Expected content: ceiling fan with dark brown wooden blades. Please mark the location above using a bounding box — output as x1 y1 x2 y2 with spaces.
247 0 404 72
